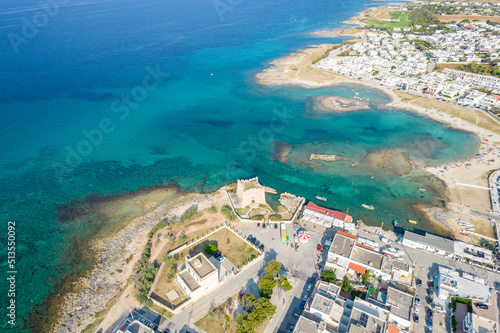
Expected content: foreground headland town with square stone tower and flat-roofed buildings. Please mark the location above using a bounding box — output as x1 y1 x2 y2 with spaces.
75 172 500 333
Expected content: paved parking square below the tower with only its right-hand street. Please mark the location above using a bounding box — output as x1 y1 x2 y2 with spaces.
231 222 336 333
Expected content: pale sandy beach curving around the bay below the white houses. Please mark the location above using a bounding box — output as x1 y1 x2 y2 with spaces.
256 5 500 238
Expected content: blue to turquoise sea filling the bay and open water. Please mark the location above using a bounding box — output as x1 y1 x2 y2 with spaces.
0 0 478 332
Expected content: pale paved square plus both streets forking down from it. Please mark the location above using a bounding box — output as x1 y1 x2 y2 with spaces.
167 222 335 333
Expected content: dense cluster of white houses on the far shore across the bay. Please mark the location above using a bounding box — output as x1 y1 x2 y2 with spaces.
316 7 500 112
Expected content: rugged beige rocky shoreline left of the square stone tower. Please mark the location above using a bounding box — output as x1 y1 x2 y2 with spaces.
52 187 226 333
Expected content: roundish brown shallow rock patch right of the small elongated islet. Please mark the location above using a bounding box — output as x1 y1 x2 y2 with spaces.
364 147 415 176
